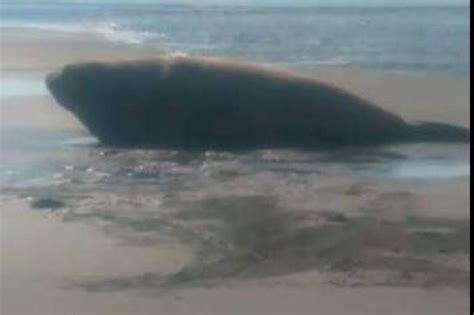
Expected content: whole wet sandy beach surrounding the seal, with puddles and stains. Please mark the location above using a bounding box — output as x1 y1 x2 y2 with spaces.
0 28 470 315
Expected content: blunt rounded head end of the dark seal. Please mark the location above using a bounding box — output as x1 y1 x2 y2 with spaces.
46 62 169 144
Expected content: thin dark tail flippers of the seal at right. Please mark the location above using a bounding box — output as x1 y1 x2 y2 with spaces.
409 122 471 142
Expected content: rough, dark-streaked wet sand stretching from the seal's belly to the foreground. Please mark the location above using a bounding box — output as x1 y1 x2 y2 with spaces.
5 147 469 291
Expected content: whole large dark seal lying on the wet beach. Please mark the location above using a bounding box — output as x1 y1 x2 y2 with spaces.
46 57 470 149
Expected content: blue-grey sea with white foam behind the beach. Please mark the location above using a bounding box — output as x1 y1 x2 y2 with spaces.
0 1 470 74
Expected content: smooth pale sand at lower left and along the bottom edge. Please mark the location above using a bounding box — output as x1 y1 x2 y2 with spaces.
2 203 469 314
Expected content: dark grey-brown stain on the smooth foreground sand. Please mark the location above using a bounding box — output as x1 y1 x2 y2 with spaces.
70 196 469 291
